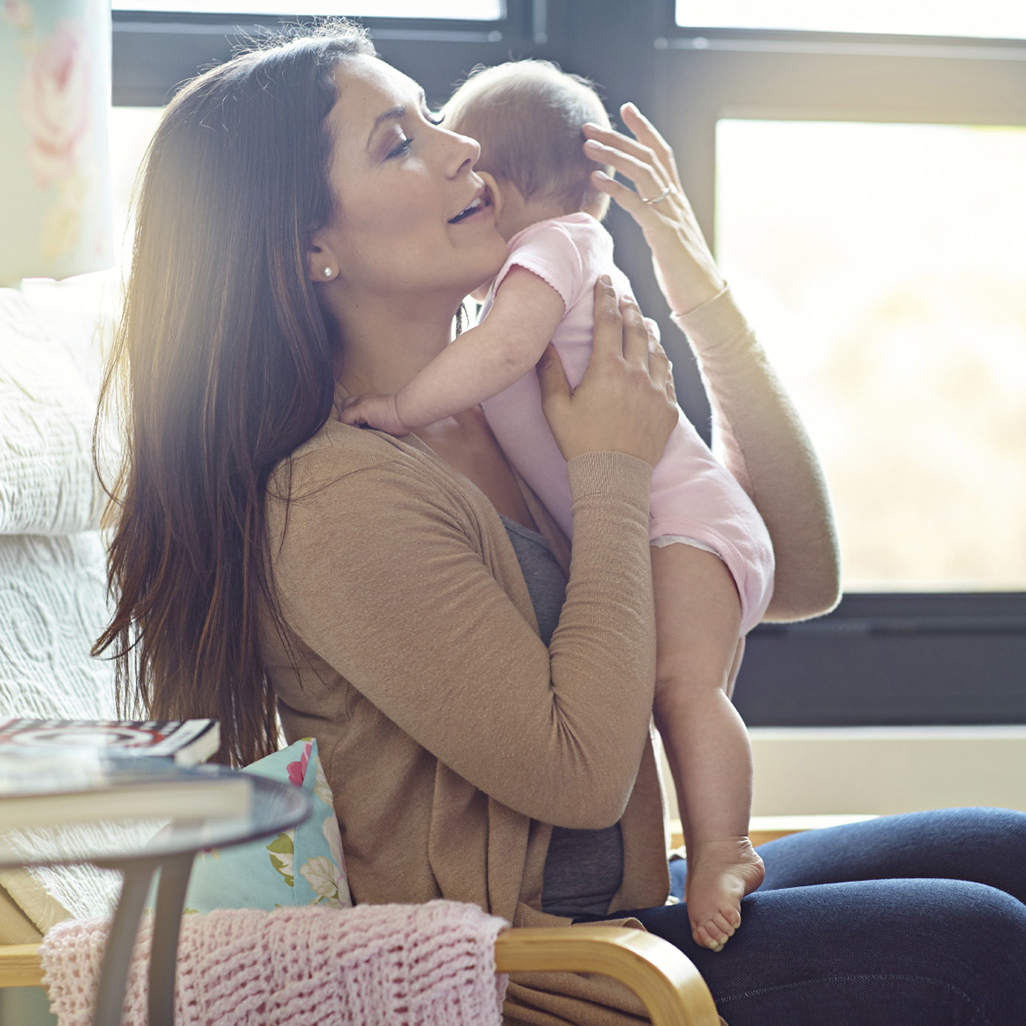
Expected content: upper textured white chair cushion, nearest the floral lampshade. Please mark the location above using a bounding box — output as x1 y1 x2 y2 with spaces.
0 288 105 535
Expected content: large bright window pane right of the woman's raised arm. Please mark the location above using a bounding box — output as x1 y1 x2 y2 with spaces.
716 120 1026 591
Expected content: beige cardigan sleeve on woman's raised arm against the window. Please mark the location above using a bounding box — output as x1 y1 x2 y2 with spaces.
672 288 840 620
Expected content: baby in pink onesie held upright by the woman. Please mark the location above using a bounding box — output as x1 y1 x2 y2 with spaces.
342 61 774 951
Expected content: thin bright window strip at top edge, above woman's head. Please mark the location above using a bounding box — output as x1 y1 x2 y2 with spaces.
113 0 506 22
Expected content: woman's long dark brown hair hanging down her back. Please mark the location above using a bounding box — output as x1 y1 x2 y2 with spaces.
93 22 373 764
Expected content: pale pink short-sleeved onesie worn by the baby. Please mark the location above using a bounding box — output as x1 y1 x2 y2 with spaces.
482 213 774 634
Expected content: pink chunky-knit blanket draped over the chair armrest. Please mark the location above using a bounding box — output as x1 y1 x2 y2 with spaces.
42 901 507 1026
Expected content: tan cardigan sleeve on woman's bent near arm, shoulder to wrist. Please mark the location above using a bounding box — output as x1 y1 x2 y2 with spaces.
272 452 655 828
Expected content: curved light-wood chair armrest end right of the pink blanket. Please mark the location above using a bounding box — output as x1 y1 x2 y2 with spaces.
496 926 720 1026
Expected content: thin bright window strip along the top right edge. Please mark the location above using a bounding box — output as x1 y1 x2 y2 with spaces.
676 0 1026 39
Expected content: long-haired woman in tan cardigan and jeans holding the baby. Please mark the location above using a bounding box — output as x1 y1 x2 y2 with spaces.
97 22 1026 1026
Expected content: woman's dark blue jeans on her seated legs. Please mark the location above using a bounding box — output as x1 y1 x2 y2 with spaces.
610 808 1026 1026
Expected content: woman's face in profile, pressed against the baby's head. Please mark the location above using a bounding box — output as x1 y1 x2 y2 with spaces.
316 56 506 303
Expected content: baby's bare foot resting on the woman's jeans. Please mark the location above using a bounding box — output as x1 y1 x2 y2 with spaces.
684 837 765 951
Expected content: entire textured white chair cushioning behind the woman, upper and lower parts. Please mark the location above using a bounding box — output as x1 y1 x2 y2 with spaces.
0 289 118 943
